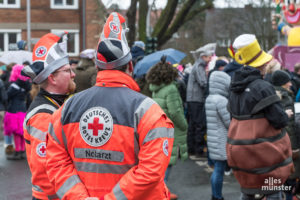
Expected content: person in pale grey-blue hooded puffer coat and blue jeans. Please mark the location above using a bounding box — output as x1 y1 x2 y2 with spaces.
205 71 230 200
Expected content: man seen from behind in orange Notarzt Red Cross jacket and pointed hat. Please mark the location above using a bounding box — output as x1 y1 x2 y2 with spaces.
46 12 174 200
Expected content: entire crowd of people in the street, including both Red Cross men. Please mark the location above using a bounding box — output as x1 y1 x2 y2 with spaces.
0 12 300 200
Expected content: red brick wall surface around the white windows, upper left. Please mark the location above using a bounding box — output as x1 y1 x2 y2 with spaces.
0 0 106 54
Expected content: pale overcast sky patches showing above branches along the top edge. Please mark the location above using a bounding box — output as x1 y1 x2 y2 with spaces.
102 0 260 9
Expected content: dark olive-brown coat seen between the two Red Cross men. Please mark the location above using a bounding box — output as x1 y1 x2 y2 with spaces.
74 58 97 92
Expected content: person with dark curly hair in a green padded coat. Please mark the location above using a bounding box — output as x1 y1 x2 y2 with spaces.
146 57 188 200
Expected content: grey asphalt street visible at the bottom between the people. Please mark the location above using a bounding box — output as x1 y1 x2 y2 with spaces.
0 141 240 200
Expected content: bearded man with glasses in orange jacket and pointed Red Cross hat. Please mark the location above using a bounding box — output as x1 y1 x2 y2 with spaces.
22 32 75 200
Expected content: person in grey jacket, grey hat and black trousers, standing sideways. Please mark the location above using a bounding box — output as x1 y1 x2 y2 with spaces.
186 44 214 159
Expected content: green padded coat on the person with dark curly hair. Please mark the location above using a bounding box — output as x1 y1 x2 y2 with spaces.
149 83 188 165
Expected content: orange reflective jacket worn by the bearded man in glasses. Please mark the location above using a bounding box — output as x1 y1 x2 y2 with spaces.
23 93 58 200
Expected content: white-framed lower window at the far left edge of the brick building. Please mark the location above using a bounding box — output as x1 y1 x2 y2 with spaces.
0 29 21 54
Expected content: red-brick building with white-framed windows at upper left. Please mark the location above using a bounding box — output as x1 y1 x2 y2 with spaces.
0 0 106 57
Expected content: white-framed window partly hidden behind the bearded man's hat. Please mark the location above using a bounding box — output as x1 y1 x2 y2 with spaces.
51 29 79 56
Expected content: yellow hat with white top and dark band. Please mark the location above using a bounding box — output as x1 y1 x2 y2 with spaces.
233 34 272 67
